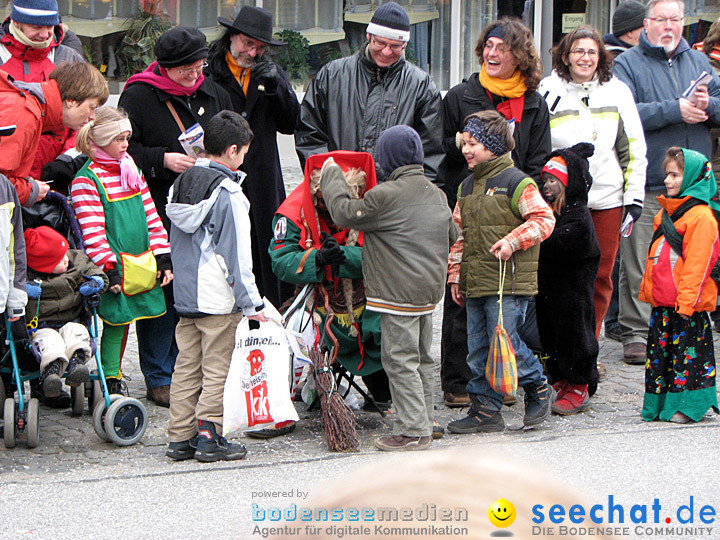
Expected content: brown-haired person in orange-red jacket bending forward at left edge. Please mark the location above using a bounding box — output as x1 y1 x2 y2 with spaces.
0 62 109 206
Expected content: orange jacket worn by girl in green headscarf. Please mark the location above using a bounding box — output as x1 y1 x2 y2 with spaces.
639 195 720 315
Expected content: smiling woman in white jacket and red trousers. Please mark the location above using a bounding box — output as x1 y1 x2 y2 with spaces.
538 26 647 342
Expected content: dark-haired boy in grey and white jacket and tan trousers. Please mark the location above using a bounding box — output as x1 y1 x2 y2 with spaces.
165 111 267 462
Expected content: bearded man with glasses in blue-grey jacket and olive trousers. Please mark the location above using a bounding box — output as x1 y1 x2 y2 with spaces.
614 0 720 364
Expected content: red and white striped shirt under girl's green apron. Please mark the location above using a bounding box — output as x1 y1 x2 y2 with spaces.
70 161 170 270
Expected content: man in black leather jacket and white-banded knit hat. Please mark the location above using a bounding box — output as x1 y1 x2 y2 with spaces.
295 2 444 181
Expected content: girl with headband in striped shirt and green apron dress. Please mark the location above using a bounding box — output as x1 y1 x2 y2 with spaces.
70 107 172 393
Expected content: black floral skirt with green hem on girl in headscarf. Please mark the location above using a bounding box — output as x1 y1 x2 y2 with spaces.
642 307 718 422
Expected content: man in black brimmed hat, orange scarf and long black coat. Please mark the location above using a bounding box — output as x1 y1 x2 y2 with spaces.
207 6 300 306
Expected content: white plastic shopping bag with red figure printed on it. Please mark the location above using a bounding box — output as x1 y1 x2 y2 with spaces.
223 299 298 437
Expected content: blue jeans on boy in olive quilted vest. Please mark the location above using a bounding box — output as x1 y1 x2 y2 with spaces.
465 295 545 411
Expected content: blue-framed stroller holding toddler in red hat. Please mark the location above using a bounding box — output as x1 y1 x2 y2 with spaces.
0 191 148 448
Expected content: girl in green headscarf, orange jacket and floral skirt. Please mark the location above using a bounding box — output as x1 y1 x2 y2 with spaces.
640 146 720 423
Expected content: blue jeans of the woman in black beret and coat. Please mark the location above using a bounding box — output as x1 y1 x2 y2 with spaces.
135 302 178 390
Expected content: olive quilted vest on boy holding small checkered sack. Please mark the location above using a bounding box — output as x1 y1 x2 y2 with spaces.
458 153 540 297
